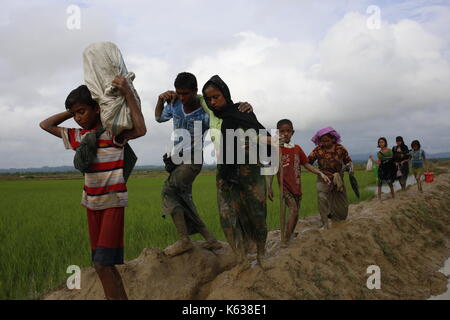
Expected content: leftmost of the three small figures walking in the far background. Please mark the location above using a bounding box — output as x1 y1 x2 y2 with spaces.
370 137 396 201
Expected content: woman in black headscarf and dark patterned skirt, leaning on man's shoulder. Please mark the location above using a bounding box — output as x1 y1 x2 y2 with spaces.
202 75 267 267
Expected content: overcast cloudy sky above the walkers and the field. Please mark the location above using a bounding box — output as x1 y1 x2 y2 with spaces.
0 0 450 168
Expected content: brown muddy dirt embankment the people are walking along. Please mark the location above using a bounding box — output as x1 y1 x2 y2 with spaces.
45 173 450 299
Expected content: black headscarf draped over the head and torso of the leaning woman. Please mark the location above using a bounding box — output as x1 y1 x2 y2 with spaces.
202 75 270 183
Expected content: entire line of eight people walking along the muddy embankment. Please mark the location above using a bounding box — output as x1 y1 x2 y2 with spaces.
40 67 424 299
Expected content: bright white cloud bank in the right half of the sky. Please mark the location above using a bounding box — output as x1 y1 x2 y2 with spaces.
190 13 450 156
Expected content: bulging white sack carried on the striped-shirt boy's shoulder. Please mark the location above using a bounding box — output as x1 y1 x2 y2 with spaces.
83 42 140 136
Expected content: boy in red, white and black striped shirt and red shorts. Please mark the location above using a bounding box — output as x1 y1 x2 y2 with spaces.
40 76 146 299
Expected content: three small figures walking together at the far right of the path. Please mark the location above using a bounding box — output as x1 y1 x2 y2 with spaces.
370 136 428 201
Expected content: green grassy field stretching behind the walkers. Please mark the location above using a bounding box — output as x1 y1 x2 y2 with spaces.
0 171 375 299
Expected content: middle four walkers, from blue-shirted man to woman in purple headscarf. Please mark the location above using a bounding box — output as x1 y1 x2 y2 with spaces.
155 72 353 267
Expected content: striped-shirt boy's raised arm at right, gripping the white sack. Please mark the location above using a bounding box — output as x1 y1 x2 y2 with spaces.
112 76 147 144
